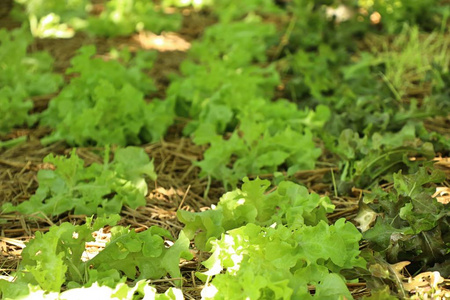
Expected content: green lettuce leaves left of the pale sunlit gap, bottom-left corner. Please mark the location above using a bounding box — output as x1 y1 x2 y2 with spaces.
0 215 120 298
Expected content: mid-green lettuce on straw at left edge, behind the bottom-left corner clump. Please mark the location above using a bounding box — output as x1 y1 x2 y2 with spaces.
2 147 156 216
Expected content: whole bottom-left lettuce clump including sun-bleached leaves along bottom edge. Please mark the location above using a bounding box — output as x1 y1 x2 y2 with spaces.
0 215 188 299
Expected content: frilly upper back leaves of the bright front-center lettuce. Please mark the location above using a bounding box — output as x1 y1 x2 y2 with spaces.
177 178 334 249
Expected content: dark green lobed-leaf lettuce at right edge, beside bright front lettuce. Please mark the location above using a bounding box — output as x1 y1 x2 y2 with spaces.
364 168 450 272
